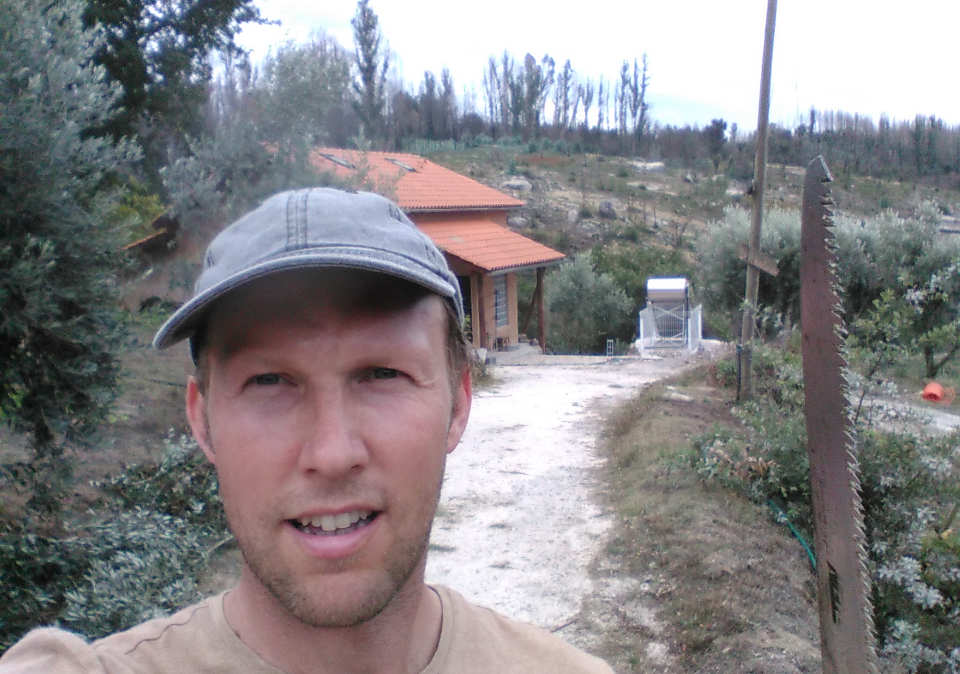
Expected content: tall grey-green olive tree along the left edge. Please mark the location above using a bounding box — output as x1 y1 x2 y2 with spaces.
0 0 135 510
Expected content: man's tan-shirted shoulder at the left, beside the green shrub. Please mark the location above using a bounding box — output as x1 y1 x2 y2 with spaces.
0 596 264 674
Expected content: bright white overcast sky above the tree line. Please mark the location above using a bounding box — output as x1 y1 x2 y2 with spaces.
234 0 960 130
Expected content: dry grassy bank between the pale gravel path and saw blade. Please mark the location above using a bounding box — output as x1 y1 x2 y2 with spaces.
599 365 819 672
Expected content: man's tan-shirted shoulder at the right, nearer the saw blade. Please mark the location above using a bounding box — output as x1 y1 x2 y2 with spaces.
425 587 612 674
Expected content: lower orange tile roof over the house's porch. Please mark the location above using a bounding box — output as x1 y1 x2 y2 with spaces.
417 218 565 272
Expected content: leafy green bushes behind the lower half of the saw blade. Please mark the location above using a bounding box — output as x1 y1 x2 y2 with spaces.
694 348 960 672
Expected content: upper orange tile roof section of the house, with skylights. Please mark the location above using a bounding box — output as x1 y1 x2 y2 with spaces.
310 148 523 213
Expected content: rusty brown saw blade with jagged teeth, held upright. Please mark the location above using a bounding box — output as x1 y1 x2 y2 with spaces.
800 157 877 674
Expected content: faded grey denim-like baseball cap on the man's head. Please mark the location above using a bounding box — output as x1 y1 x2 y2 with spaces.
153 187 463 349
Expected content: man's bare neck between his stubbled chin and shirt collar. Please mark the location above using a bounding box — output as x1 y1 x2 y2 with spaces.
224 569 443 674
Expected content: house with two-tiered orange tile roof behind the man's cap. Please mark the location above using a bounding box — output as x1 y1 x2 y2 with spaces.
311 148 564 349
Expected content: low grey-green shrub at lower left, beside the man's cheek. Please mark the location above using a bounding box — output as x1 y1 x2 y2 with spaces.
0 436 227 651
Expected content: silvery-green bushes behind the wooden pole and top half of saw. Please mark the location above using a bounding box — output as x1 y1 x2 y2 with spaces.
697 203 960 378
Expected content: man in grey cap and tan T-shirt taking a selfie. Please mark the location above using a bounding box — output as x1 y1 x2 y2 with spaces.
0 189 610 674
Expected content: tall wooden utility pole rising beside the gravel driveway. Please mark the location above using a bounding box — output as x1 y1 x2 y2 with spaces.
737 0 777 400
